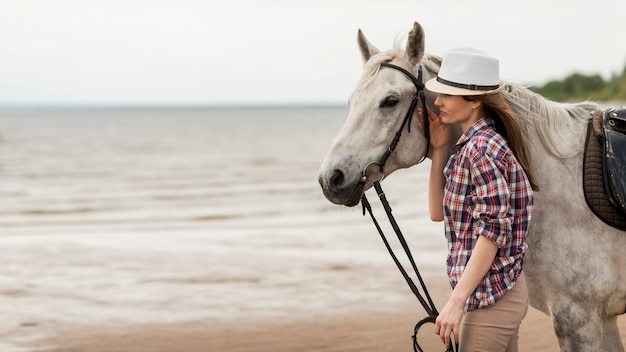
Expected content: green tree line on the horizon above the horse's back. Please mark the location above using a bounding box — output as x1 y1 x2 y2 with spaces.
528 66 626 102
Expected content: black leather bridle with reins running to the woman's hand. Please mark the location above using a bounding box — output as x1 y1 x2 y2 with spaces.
361 62 458 352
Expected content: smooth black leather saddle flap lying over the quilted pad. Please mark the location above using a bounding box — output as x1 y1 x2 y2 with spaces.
603 108 626 212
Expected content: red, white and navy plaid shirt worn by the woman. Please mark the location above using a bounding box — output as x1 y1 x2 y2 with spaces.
443 118 533 311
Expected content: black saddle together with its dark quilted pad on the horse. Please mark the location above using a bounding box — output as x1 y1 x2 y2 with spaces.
583 107 626 231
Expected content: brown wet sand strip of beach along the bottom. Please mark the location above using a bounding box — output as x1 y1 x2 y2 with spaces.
42 292 626 352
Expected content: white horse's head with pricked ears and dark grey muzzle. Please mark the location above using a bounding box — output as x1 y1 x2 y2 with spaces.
319 22 440 206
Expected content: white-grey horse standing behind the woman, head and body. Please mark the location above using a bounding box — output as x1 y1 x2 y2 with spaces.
319 22 626 352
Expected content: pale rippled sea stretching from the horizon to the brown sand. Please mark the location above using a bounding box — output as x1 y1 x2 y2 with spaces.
0 106 446 351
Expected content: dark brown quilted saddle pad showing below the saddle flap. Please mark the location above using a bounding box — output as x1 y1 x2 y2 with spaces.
583 122 626 231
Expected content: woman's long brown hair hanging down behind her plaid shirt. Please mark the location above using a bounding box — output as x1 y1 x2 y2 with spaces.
463 93 539 191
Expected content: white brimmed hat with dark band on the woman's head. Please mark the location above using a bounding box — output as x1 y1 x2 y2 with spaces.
426 48 503 95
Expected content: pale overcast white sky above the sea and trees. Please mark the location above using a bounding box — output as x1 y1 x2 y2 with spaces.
0 0 626 107
